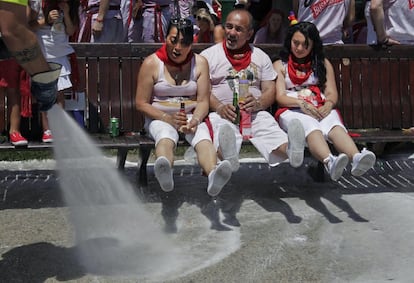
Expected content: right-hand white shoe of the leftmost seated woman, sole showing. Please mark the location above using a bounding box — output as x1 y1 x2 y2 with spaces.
207 160 232 197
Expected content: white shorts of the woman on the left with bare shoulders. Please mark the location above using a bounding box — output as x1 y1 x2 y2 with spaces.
145 114 211 147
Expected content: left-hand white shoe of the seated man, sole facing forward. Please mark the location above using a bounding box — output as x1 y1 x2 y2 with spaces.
218 124 240 172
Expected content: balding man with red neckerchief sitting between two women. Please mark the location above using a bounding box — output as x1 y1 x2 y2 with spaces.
201 9 304 171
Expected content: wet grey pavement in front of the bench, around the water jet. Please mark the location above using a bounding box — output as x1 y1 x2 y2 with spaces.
0 146 414 282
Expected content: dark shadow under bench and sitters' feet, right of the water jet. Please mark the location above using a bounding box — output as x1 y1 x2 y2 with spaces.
140 155 414 232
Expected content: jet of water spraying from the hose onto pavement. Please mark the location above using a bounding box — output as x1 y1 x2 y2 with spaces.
48 105 184 277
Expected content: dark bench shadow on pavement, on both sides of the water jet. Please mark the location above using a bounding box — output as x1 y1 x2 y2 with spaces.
0 146 414 233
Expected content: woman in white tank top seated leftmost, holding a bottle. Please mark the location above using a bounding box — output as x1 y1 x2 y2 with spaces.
136 19 232 196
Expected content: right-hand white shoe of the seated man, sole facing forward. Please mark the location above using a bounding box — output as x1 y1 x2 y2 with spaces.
287 119 306 168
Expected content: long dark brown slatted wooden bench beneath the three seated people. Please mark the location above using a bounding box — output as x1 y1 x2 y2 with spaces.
0 43 414 186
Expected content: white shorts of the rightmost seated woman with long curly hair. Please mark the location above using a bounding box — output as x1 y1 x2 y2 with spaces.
279 109 348 141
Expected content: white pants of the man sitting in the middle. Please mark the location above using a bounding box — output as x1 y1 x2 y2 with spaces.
209 111 288 166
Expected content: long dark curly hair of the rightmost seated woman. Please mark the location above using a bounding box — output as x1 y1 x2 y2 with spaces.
279 22 326 90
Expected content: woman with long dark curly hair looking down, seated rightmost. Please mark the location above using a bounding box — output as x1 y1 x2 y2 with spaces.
273 22 376 181
